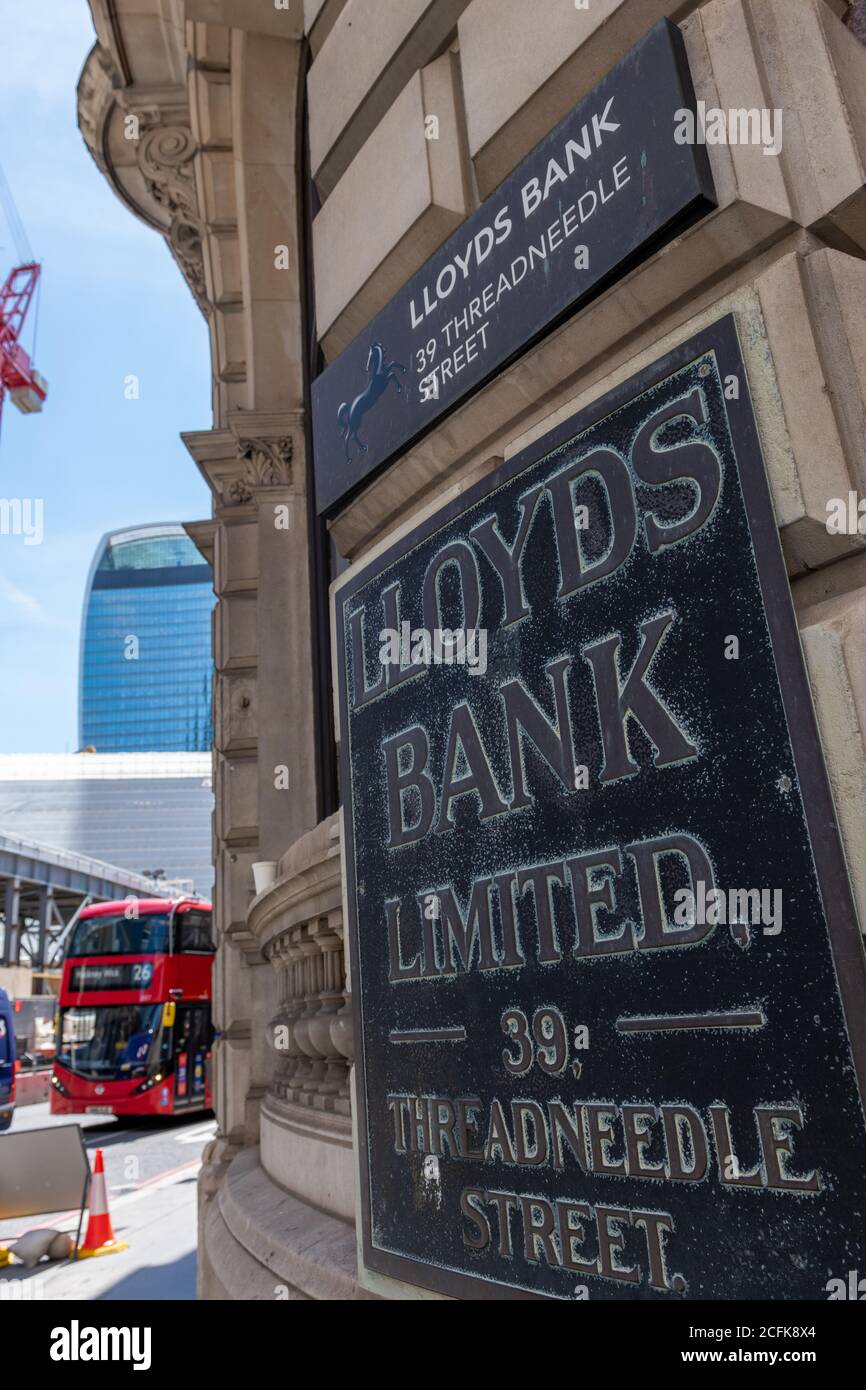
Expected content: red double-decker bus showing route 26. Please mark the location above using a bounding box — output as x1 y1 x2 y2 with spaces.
50 898 214 1115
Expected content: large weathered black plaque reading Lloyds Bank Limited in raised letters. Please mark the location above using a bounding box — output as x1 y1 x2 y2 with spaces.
336 317 866 1300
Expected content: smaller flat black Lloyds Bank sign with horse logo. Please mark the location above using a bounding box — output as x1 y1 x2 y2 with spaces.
313 19 714 513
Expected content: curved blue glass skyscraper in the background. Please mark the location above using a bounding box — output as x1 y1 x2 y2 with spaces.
79 524 214 753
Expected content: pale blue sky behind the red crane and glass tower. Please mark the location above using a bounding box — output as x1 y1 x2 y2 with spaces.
0 0 211 752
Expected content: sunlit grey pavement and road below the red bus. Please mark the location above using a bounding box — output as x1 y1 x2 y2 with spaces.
0 1104 217 1295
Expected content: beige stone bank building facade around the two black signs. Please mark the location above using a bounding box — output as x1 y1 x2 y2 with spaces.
78 0 866 1300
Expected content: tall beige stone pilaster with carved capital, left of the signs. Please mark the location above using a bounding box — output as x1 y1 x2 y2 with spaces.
185 21 318 1295
